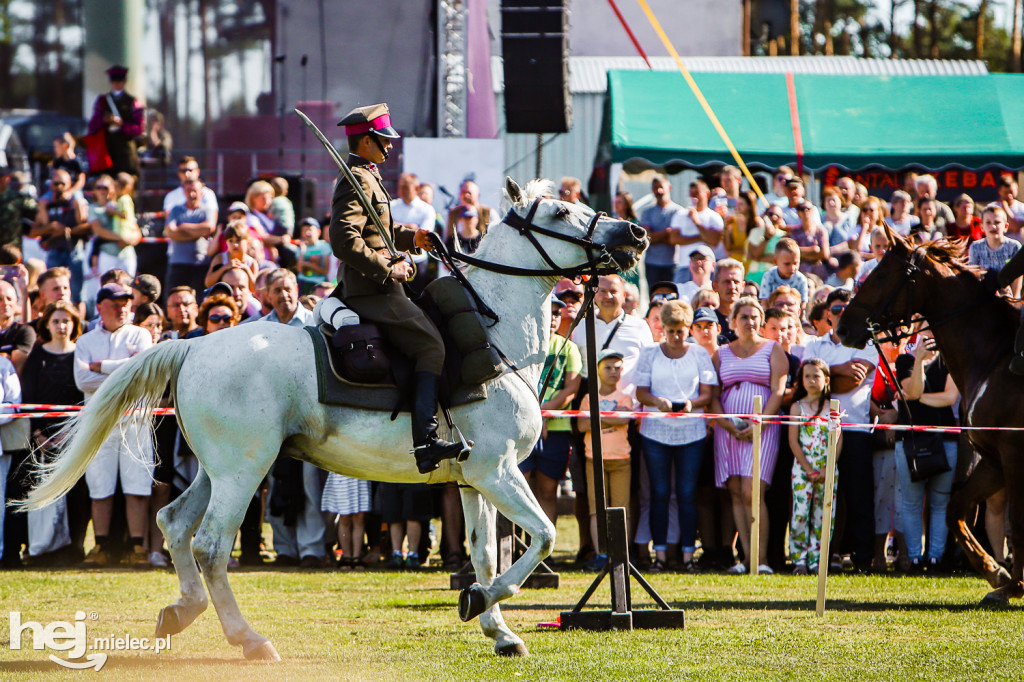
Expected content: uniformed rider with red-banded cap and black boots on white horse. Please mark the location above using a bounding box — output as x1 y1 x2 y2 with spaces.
330 103 462 473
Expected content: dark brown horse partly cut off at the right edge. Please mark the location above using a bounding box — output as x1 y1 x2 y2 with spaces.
836 227 1024 604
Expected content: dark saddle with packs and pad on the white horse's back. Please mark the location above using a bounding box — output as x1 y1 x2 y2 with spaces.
305 278 503 419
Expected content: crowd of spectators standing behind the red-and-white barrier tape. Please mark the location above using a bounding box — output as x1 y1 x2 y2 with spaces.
0 146 1024 573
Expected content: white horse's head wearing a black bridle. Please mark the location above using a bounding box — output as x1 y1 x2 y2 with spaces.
476 178 648 276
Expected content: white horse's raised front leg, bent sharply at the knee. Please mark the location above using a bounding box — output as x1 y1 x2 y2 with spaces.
459 457 555 621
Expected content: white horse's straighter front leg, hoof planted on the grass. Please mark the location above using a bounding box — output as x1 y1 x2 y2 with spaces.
460 487 528 656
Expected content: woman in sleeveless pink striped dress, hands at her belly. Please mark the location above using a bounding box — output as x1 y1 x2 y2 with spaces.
712 296 788 573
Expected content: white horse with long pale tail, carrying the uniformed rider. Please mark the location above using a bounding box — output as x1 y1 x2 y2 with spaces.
26 179 647 660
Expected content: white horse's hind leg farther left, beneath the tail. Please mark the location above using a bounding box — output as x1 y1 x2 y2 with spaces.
157 468 210 637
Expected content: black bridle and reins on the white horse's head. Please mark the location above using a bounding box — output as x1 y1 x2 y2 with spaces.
442 198 618 280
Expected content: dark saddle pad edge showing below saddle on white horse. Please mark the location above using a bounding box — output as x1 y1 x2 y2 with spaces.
304 327 487 413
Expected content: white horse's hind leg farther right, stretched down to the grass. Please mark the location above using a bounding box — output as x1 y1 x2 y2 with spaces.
193 455 281 660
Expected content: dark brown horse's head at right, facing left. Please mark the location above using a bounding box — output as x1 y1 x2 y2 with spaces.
836 225 934 348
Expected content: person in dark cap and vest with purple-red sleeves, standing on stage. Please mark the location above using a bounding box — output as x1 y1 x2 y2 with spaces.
89 66 145 176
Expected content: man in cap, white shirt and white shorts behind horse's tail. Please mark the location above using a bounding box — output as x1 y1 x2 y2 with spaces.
75 283 154 566
